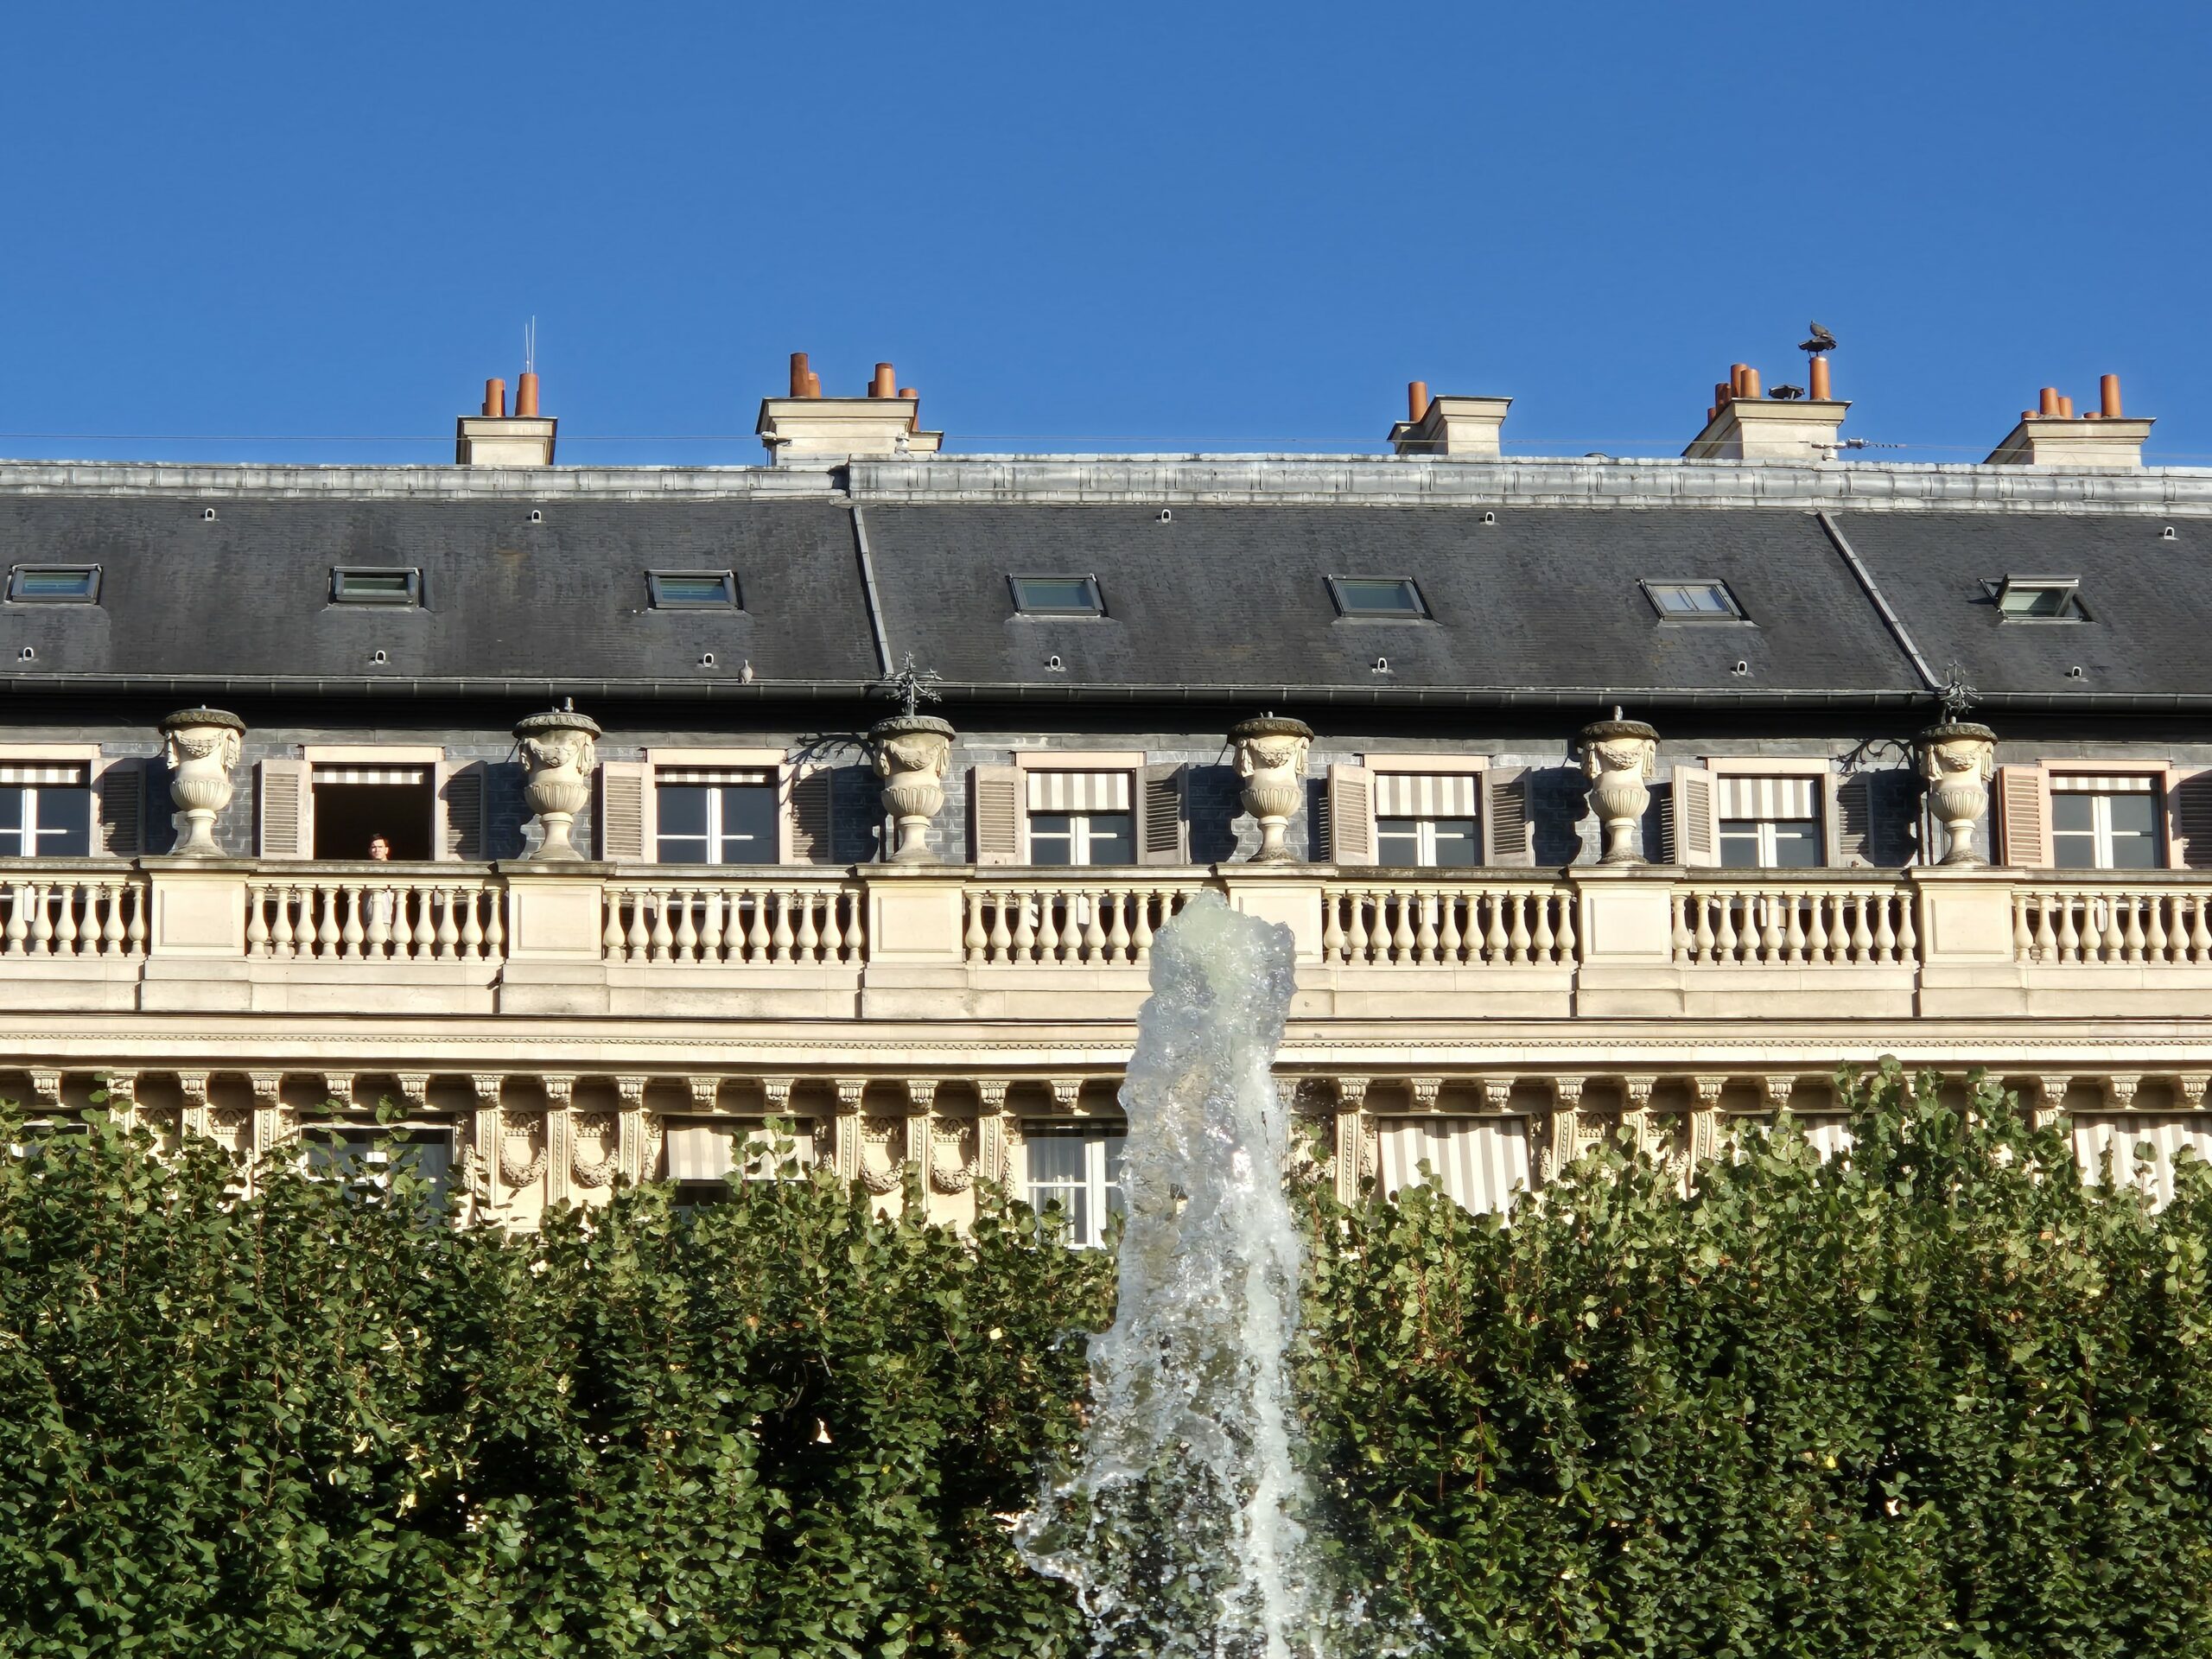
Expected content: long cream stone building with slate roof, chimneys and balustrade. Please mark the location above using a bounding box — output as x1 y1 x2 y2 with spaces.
0 378 2212 1236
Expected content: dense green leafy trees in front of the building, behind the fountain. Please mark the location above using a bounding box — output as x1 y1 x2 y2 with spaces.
0 1071 2212 1659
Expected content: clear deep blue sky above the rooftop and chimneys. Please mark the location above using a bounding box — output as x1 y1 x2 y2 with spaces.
0 0 2212 465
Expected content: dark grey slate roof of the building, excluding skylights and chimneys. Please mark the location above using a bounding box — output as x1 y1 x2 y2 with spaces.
0 458 2212 708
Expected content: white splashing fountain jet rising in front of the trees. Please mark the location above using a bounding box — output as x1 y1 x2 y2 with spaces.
1018 893 1325 1659
